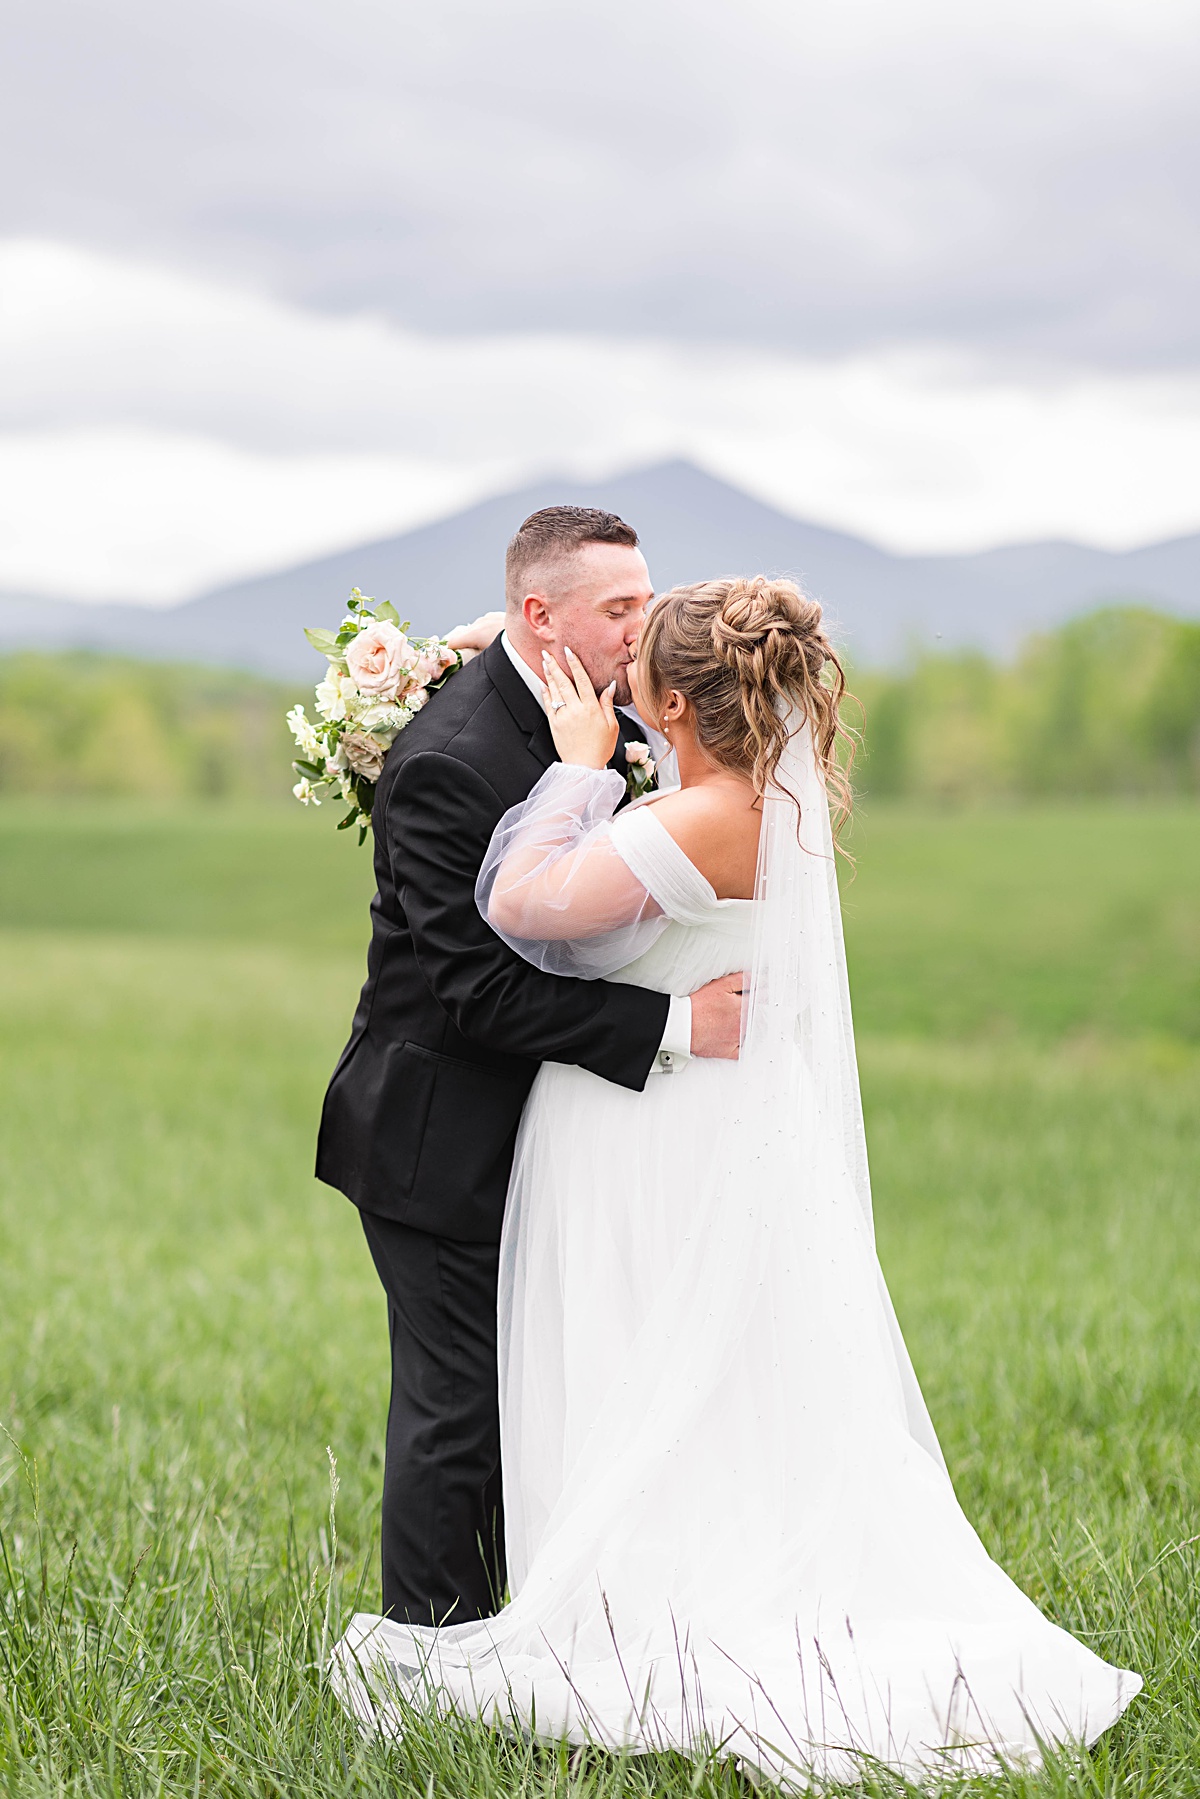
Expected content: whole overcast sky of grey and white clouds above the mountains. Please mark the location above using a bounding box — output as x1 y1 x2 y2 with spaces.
0 0 1200 601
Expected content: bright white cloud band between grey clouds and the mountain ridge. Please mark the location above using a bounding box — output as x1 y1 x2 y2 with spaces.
0 241 1200 601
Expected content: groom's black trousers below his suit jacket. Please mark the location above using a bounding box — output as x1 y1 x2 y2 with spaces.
362 1213 506 1624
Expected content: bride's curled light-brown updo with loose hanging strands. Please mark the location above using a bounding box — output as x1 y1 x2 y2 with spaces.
637 574 855 829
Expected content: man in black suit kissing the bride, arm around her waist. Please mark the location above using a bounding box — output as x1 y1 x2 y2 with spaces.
317 506 741 1624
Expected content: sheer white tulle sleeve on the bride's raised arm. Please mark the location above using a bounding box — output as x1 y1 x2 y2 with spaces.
475 763 667 980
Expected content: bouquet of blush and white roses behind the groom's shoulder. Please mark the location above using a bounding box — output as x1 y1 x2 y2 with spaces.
288 588 466 844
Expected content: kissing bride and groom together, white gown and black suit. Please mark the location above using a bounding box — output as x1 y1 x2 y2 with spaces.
318 506 1141 1786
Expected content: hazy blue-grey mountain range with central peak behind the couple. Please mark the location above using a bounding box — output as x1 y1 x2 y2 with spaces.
0 462 1200 678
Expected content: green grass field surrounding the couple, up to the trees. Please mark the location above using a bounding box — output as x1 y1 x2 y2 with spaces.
0 806 1200 1799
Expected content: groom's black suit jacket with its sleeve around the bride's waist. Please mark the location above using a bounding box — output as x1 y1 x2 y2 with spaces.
317 639 669 1243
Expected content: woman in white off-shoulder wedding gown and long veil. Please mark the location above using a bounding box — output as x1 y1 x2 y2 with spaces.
335 577 1141 1785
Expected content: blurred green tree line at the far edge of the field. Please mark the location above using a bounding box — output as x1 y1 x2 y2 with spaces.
0 606 1200 802
